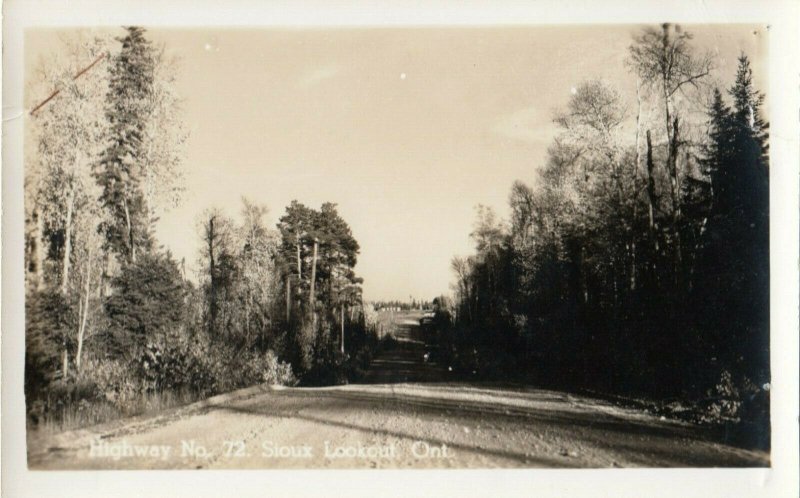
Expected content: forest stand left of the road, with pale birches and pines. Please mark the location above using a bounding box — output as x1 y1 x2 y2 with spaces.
25 27 378 429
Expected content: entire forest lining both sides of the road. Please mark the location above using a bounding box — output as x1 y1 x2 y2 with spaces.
25 24 771 446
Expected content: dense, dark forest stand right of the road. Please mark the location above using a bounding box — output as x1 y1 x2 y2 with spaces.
437 24 770 445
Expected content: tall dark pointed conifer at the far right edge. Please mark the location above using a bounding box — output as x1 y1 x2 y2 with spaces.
696 55 769 380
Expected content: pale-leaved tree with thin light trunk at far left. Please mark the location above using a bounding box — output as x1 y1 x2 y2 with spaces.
25 38 116 378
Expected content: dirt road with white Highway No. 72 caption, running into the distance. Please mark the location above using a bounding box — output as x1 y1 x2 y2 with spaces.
28 315 768 469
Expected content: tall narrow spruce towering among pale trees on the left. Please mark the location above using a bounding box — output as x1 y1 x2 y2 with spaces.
96 26 186 268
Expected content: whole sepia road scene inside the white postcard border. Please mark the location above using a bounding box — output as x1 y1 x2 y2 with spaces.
23 23 772 470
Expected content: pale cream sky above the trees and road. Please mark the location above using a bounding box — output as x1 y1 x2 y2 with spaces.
26 26 767 300
